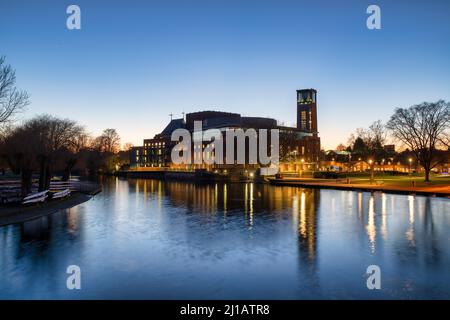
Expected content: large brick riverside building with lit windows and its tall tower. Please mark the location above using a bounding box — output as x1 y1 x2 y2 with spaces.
130 89 320 174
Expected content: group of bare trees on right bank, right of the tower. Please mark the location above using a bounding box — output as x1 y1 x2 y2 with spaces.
338 100 450 181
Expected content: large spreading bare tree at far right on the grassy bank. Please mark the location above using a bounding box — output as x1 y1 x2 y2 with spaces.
387 100 450 181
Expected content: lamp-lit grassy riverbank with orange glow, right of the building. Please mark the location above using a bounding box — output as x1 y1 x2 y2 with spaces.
270 178 450 198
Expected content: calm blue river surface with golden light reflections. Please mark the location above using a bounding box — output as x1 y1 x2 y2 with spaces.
0 179 450 299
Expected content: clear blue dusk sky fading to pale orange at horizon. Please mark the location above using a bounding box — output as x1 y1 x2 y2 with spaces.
0 0 450 149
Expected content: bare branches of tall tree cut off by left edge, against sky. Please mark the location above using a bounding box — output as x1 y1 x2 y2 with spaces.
0 57 29 125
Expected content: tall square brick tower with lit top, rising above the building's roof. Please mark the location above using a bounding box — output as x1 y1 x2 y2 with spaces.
297 89 317 137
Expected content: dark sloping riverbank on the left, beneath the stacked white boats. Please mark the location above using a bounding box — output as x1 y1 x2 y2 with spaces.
0 193 92 226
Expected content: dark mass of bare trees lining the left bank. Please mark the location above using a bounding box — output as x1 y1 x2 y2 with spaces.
0 58 131 196
